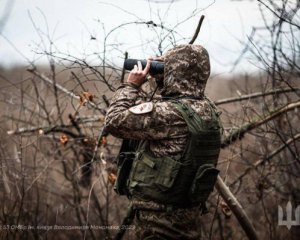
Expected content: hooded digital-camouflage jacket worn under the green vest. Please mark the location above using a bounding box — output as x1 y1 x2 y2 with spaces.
105 45 211 157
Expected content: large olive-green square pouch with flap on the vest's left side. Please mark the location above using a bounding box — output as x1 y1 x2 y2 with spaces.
129 153 182 202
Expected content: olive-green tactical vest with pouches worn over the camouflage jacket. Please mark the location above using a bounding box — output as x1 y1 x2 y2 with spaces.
113 101 221 207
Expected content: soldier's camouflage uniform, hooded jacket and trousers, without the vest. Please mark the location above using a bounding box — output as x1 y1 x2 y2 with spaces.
106 45 212 239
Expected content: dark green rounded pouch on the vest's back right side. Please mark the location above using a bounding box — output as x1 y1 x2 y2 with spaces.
189 164 219 203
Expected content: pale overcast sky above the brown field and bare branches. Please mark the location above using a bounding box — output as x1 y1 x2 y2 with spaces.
0 0 270 73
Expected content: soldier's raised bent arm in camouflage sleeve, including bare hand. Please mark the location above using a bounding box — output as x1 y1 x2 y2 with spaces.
105 60 186 139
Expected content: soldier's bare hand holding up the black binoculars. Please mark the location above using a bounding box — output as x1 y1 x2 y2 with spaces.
127 59 151 87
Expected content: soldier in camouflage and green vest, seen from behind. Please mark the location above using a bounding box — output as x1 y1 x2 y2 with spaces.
106 45 221 240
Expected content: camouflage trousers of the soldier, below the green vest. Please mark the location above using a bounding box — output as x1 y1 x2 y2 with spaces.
134 201 200 240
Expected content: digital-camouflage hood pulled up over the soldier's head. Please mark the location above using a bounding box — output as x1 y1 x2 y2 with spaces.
161 45 210 97
